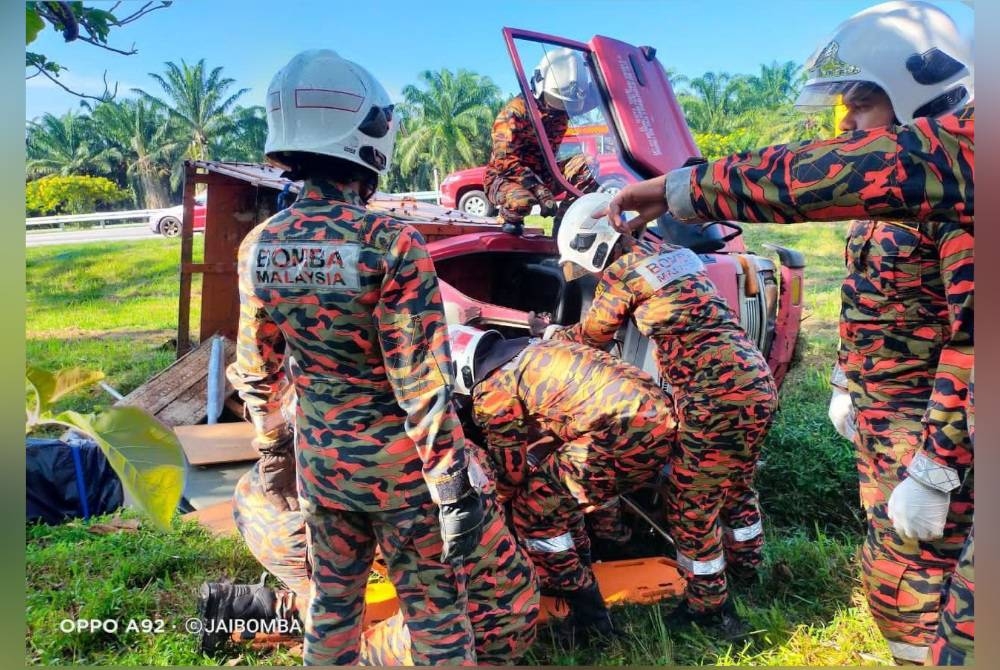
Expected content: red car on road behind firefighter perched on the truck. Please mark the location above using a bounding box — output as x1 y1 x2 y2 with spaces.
440 123 636 216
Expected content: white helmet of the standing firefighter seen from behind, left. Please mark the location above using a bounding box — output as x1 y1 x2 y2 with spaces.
264 49 398 175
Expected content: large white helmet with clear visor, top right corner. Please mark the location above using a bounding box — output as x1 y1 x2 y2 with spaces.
795 0 974 124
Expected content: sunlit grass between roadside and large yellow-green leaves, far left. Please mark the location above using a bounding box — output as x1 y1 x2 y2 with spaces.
25 235 204 412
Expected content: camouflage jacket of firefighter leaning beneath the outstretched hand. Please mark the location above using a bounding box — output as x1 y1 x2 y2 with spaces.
552 241 773 410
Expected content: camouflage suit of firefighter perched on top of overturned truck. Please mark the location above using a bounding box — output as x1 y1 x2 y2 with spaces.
483 96 598 223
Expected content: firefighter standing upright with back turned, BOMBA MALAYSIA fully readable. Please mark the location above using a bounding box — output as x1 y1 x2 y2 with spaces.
222 50 484 665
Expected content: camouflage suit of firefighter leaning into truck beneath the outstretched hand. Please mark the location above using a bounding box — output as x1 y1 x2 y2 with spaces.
553 241 776 611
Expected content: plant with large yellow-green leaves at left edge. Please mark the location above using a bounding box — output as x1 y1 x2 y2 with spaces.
25 366 186 530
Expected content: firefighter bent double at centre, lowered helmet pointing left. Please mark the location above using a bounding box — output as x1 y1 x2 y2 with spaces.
449 325 677 640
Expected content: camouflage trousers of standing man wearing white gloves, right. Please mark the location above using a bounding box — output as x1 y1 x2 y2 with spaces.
845 355 973 663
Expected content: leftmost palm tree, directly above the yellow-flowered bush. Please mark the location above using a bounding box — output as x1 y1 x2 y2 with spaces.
25 111 113 177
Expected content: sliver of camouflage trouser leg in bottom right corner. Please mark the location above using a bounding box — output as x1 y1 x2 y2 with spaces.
928 530 976 665
